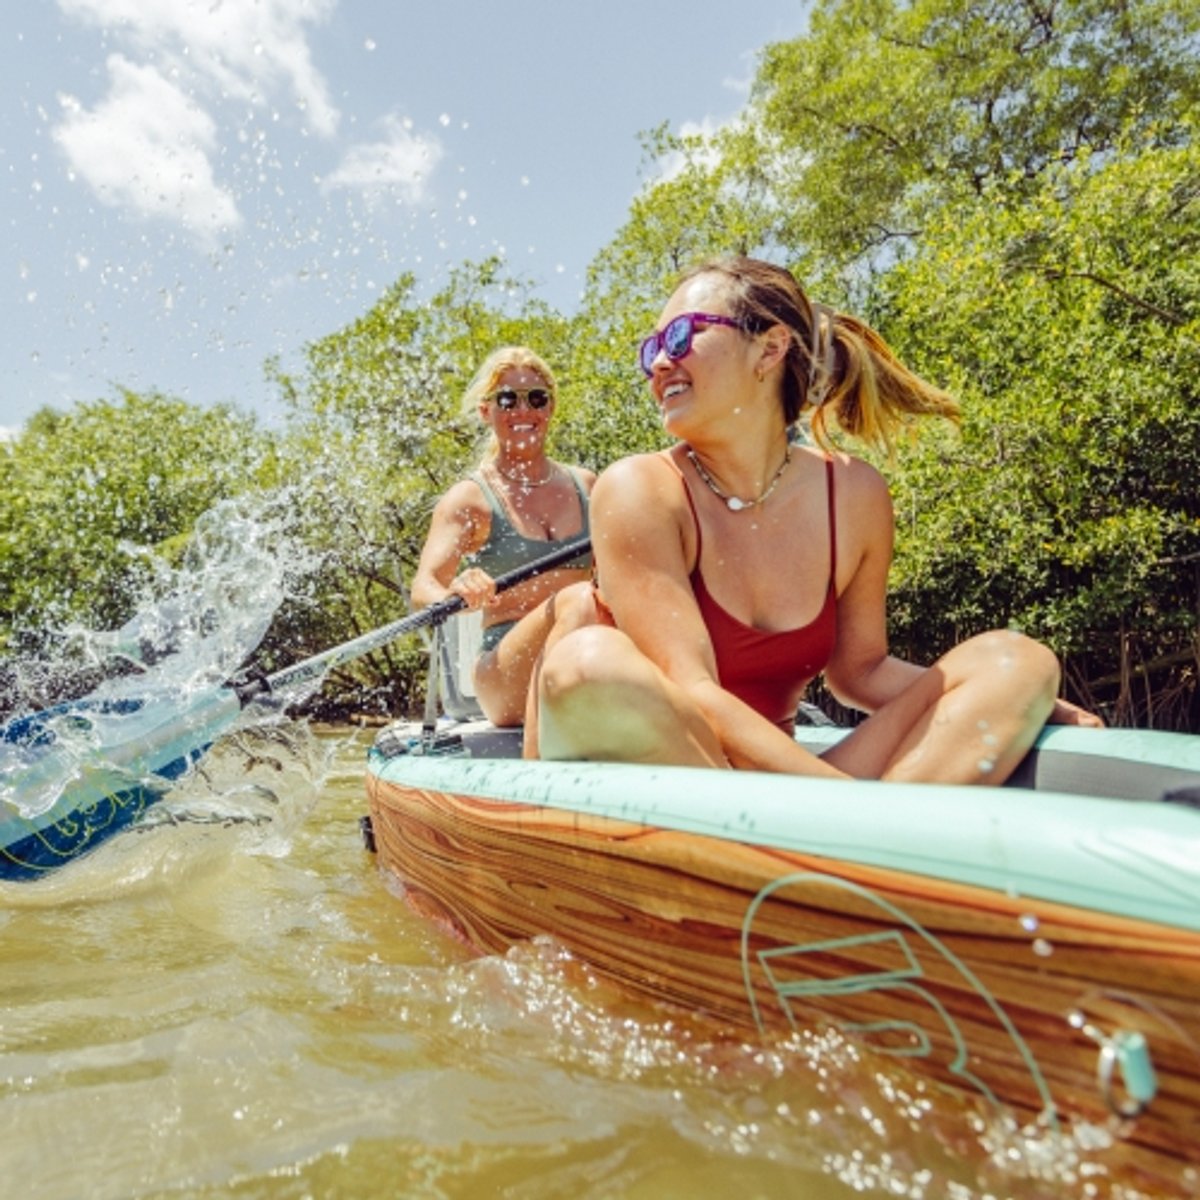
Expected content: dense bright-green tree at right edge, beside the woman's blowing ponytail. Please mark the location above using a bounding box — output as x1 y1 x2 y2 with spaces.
880 142 1200 727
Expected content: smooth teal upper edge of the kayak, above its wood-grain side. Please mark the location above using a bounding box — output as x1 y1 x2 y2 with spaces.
368 728 1200 930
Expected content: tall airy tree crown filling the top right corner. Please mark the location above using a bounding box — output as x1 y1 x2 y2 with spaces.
743 0 1200 282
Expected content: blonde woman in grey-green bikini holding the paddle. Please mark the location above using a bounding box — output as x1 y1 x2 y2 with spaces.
413 346 595 726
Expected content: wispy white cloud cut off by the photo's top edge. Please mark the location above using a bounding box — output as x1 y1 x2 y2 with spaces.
59 0 338 137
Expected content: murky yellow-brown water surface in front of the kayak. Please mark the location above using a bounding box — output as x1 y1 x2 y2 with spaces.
0 731 1190 1200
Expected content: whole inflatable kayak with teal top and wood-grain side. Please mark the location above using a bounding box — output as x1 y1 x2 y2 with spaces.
364 722 1200 1194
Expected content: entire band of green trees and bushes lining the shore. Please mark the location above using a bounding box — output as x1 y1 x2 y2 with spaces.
0 0 1200 732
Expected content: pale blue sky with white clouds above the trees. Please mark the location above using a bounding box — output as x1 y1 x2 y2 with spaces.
0 0 806 427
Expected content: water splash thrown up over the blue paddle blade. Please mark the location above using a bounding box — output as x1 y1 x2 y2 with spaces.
0 492 317 830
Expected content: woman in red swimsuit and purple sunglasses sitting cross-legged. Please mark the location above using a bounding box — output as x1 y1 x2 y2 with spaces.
527 258 1100 784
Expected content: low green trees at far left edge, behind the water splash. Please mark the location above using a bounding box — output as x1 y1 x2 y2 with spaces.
0 389 270 649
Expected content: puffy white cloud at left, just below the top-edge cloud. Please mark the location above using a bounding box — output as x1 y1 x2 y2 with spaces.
54 54 240 241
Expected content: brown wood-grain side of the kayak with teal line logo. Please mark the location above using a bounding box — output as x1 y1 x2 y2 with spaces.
367 773 1200 1190
